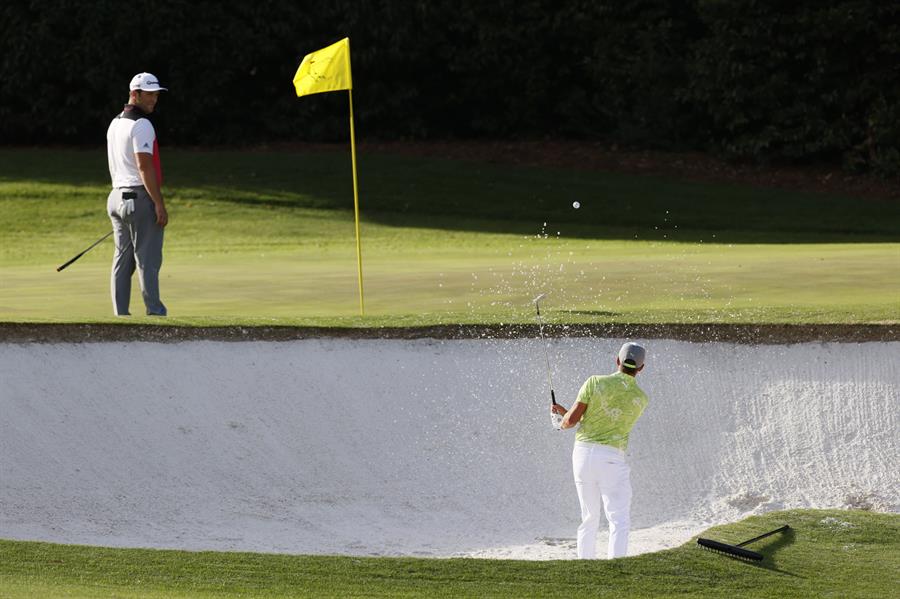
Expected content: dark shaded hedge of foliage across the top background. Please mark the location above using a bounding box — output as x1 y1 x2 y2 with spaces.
0 0 900 175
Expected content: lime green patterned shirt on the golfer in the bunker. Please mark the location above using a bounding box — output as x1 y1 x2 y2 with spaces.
575 372 649 451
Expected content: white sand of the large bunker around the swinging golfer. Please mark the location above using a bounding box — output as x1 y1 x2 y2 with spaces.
0 339 900 559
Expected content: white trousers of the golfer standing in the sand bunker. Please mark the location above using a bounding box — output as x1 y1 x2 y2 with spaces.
572 441 631 559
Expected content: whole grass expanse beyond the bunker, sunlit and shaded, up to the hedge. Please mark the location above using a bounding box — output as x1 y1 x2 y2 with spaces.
0 150 900 326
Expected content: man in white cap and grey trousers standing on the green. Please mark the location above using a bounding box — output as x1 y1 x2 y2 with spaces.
106 73 169 316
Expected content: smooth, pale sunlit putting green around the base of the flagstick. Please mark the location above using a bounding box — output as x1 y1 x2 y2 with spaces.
0 237 900 323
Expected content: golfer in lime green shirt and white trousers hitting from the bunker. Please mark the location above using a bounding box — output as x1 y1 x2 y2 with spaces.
552 343 648 559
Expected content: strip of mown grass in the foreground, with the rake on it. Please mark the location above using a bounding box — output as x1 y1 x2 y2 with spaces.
0 510 900 599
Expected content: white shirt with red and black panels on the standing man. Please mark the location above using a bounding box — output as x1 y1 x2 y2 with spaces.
106 108 162 187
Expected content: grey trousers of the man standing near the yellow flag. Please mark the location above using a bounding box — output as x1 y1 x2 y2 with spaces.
106 187 166 316
